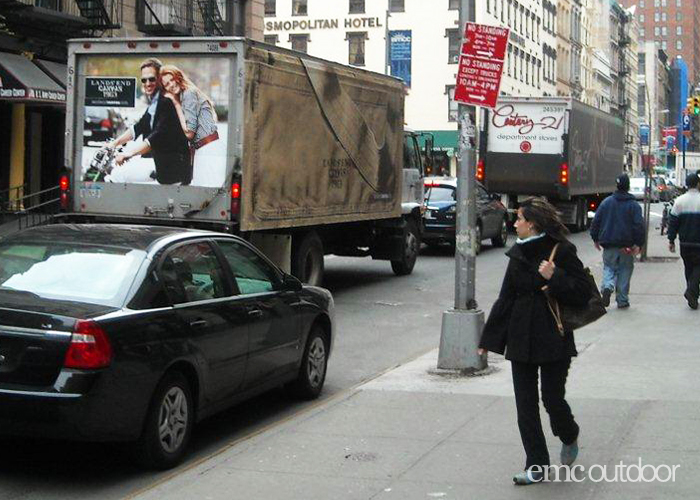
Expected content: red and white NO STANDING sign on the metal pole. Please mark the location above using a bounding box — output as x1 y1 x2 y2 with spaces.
455 23 510 108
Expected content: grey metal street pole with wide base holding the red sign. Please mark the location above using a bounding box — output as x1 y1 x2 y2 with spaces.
437 0 486 371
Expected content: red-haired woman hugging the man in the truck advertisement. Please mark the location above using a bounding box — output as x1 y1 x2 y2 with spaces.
160 65 223 187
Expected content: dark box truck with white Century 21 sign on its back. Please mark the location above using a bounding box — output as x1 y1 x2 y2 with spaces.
477 97 624 231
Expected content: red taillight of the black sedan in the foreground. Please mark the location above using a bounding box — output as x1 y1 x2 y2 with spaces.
63 320 112 370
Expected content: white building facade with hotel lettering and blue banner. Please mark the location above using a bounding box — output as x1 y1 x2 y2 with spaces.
264 0 557 172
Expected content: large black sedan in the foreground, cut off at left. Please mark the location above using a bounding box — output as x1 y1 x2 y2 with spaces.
0 224 334 468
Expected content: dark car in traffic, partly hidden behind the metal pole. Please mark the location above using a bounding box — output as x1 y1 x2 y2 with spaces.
422 177 508 253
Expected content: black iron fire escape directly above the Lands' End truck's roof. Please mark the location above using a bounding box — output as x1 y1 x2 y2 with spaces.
136 0 231 36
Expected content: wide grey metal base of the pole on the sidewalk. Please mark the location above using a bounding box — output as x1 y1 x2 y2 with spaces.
437 309 486 371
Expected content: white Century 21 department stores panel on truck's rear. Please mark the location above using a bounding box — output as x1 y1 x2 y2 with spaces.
488 102 567 155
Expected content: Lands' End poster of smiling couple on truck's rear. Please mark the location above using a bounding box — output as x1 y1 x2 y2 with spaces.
81 54 231 188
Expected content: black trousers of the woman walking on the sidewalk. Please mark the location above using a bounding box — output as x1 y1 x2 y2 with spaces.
511 358 579 468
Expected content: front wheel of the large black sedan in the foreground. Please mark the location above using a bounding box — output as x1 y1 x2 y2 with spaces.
291 325 328 400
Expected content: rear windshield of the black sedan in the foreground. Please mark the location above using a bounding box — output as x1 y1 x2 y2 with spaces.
0 242 146 307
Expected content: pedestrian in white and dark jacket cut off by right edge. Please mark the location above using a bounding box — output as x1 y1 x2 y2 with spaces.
668 174 700 309
